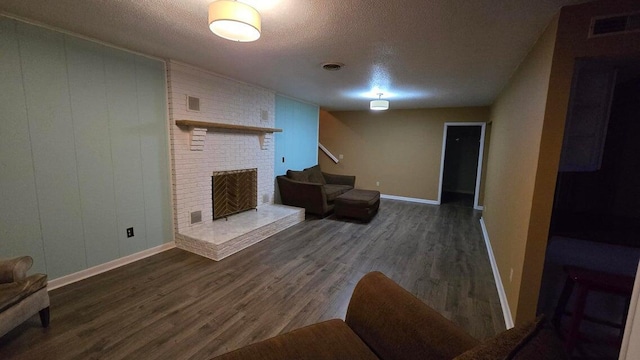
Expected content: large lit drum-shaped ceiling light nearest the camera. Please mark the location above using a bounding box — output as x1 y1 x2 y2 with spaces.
209 0 262 42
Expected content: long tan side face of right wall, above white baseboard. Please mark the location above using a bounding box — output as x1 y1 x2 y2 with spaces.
483 15 557 321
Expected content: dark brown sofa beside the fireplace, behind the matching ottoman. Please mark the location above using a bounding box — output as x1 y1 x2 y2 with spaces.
276 165 356 216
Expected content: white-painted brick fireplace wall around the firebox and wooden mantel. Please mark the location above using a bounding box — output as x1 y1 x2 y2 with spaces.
167 61 275 233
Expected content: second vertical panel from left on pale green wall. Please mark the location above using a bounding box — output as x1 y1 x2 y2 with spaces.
18 23 85 276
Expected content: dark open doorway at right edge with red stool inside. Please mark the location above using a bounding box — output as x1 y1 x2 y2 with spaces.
538 58 640 359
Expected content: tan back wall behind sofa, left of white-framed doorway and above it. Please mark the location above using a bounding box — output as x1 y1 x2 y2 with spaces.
318 107 489 201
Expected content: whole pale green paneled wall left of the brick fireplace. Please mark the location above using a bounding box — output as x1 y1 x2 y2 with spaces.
0 17 172 279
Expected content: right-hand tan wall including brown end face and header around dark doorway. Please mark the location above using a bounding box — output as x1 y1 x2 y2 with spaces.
483 0 640 324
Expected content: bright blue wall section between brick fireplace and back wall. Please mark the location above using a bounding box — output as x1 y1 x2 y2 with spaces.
275 95 319 175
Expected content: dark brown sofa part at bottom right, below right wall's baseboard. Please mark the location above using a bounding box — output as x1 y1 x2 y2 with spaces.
454 316 568 360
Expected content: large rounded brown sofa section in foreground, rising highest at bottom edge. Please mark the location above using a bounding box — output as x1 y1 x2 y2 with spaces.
345 272 479 360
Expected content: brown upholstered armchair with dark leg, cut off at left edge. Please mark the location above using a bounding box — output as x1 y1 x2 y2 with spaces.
0 256 49 336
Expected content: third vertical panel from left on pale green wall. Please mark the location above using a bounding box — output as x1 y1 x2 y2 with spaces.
66 39 119 266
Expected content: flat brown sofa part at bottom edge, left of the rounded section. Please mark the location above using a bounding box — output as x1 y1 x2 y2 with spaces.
214 319 377 360
